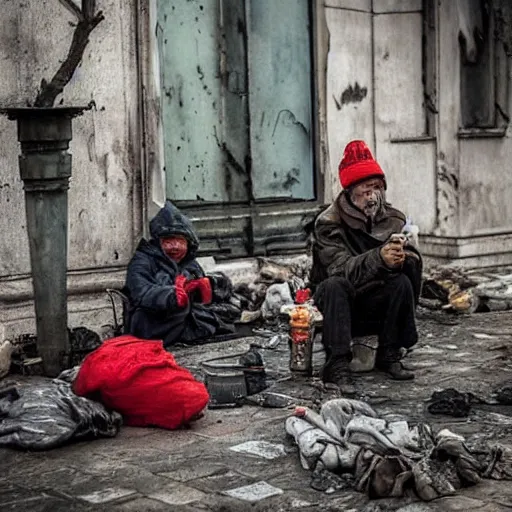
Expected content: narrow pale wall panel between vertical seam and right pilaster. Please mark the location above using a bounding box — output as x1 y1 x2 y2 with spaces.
373 4 436 233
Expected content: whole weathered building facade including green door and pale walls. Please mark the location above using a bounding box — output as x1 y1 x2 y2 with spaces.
0 0 512 338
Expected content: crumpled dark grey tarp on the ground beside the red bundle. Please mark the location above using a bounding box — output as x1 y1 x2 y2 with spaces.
0 371 122 450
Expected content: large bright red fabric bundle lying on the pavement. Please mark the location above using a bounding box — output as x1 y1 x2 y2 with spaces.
73 335 209 429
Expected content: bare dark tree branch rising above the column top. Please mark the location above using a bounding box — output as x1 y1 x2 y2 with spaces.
34 0 105 107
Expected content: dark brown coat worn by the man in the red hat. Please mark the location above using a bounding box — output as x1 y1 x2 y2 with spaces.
310 192 422 296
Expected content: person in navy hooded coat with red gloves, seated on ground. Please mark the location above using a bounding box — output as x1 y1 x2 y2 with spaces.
123 201 232 347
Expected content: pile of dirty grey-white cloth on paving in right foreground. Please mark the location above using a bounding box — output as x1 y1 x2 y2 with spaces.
286 399 512 501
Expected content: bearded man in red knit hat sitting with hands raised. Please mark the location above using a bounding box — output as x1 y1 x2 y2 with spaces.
311 141 422 393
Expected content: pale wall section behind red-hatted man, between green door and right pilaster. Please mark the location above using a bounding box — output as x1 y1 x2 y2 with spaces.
325 0 436 233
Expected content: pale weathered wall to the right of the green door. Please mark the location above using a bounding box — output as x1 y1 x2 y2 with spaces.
320 0 512 265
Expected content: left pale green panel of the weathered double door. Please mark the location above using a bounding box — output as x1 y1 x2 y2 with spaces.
157 0 228 201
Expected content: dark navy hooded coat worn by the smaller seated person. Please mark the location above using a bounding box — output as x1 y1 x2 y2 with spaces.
123 201 230 346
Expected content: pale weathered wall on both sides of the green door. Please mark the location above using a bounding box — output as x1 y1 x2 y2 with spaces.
0 0 512 339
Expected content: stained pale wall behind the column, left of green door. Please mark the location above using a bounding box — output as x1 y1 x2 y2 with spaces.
0 0 141 339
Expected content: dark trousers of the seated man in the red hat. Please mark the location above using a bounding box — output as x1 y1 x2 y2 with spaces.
315 273 418 363
